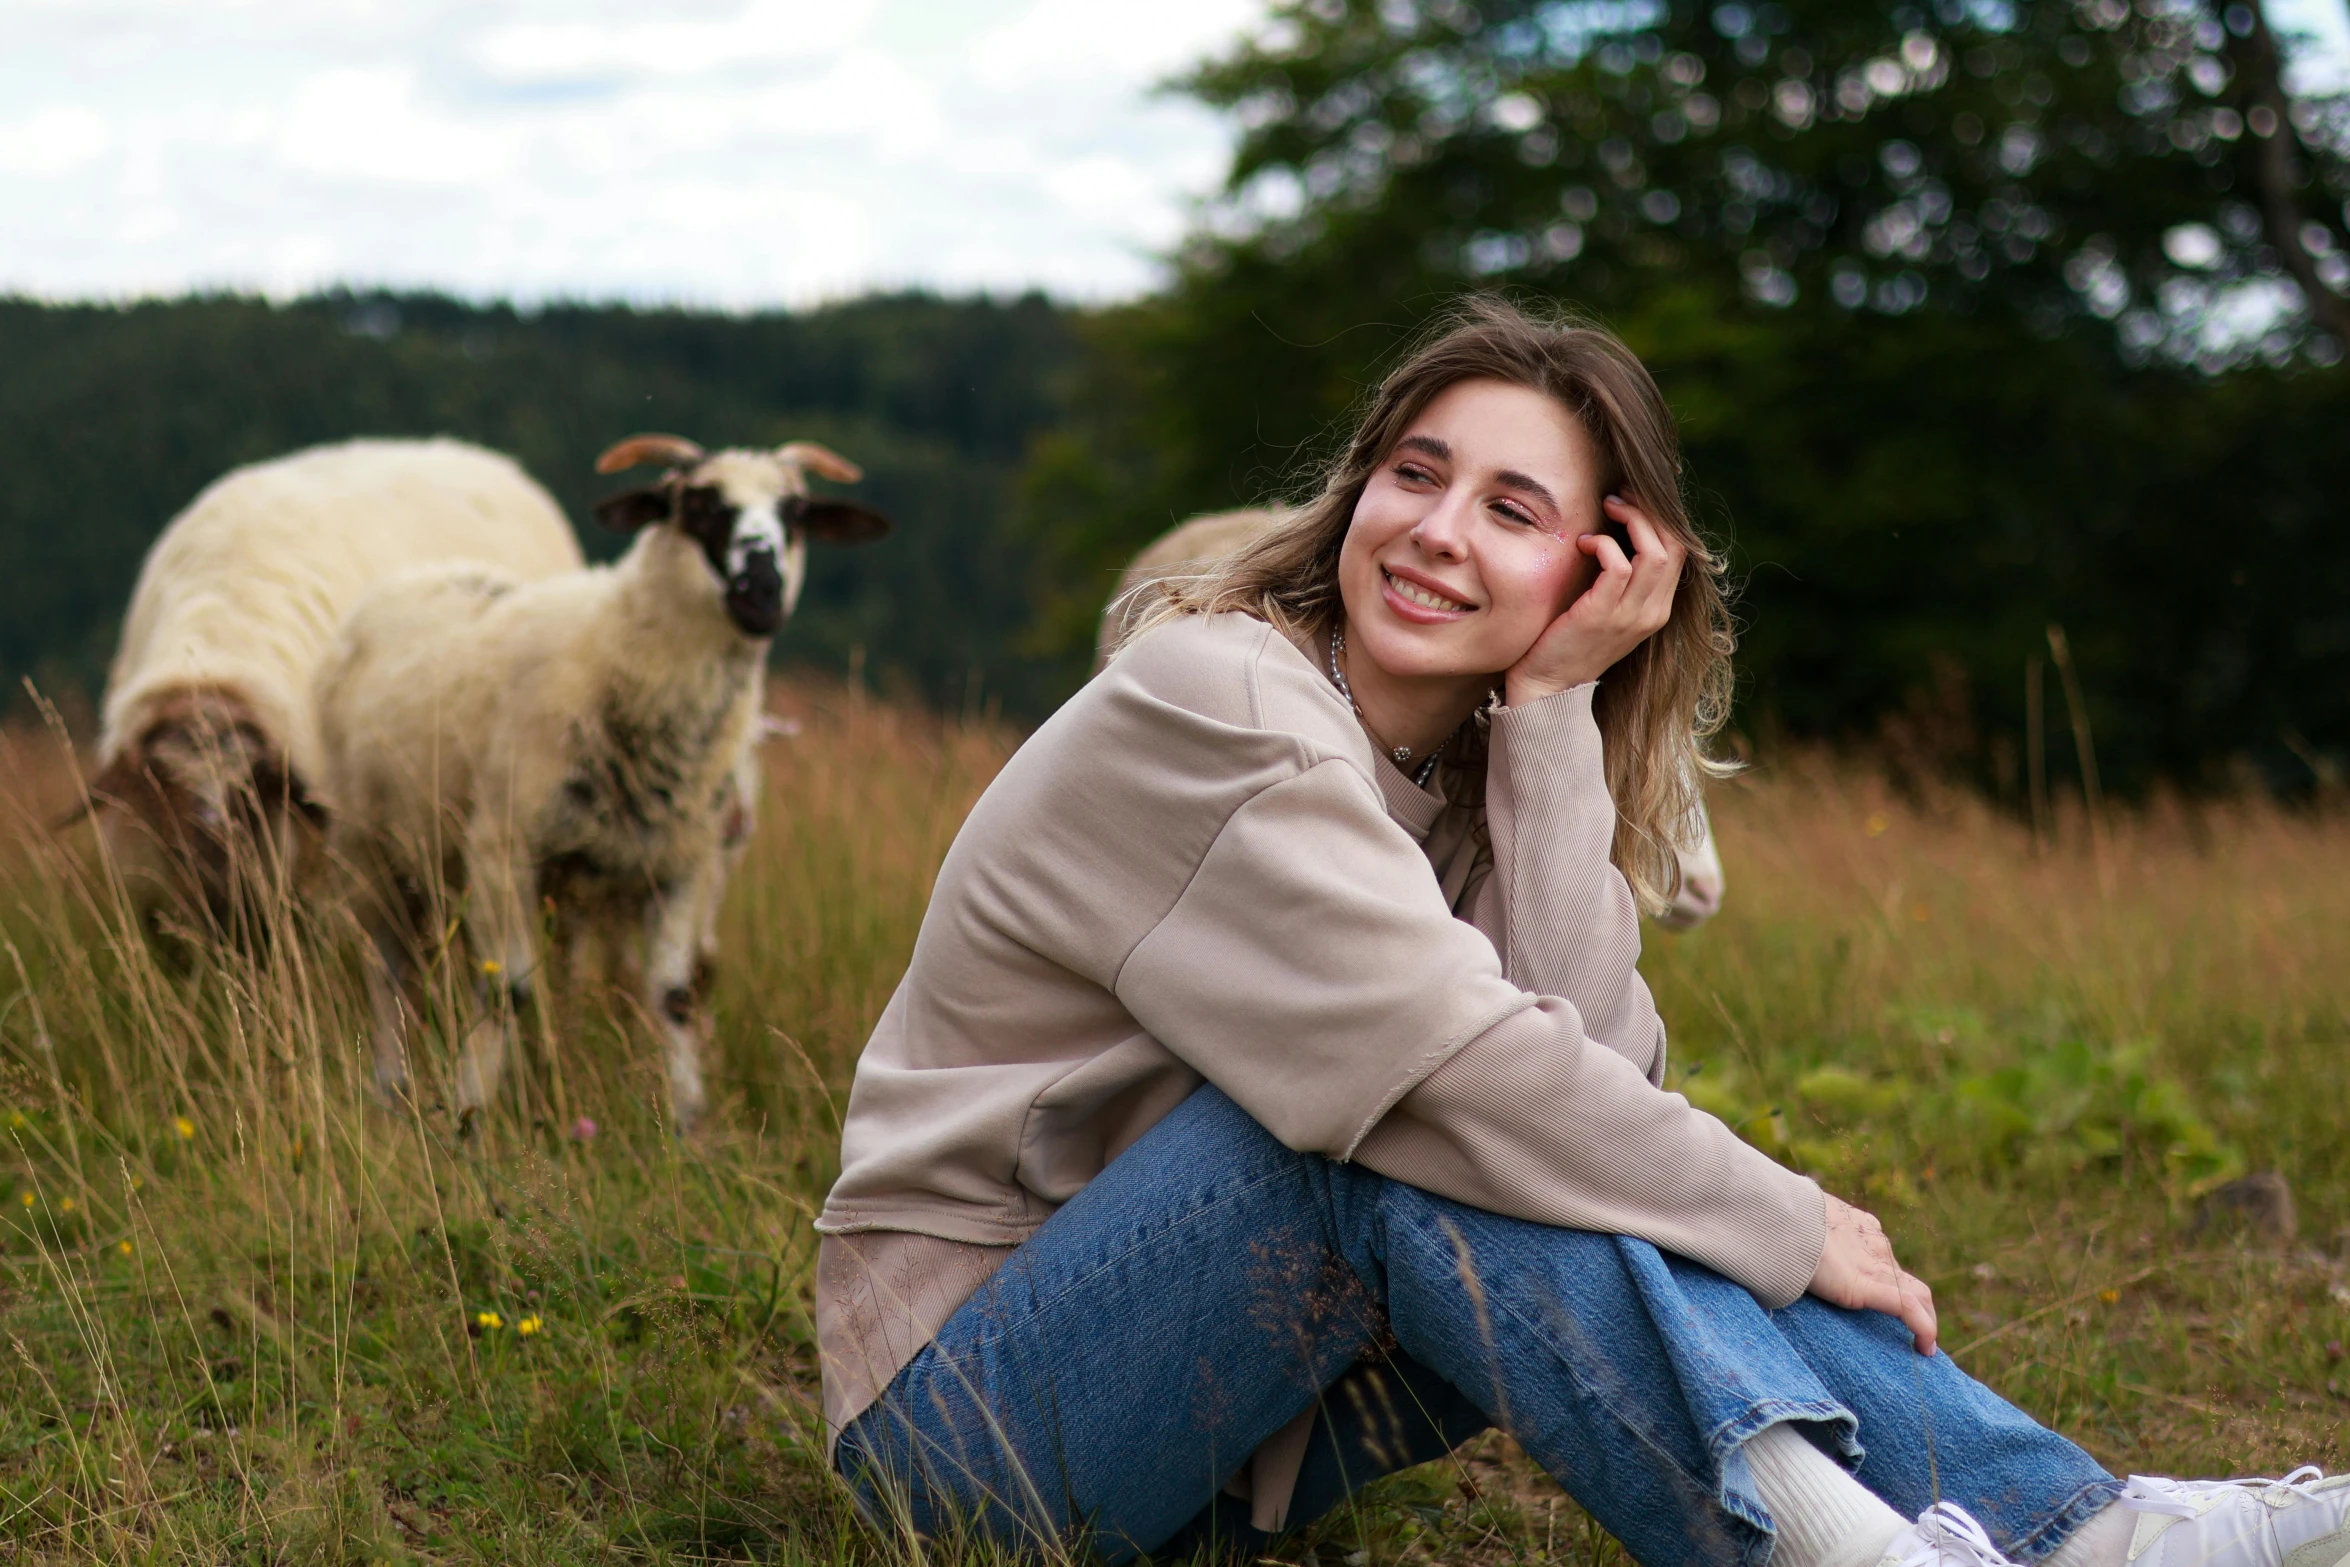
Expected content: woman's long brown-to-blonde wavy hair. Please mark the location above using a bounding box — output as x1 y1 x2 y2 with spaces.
1119 294 1737 912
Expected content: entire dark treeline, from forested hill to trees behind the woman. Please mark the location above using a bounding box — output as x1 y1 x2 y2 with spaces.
0 0 2350 808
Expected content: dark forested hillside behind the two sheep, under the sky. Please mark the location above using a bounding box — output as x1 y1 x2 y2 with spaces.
0 296 1079 717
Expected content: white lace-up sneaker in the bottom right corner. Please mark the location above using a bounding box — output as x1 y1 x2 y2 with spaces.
2122 1464 2350 1567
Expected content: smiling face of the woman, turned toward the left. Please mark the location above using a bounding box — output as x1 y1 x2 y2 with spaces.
1337 381 1600 679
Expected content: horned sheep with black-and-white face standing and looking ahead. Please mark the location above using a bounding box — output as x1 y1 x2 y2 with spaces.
317 435 888 1130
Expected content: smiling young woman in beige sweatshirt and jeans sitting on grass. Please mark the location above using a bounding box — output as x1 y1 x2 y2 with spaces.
815 301 2350 1567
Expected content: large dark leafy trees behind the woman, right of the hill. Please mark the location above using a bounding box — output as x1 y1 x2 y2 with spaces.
1022 0 2350 789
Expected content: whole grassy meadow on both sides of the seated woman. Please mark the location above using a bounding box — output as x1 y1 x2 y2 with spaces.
0 686 2350 1567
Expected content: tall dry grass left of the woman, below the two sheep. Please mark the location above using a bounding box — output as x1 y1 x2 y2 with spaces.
0 688 1011 1562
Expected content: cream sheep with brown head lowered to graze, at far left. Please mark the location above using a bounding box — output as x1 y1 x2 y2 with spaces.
92 439 583 935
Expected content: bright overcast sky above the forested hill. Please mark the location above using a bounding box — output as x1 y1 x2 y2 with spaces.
0 0 2350 305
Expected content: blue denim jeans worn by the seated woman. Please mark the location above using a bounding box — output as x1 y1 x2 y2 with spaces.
837 1088 2120 1567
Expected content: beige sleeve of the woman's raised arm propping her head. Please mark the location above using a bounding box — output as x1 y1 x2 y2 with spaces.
1462 684 1664 1083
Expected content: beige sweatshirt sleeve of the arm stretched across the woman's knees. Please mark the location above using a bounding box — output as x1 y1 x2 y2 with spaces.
1114 759 1824 1299
